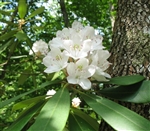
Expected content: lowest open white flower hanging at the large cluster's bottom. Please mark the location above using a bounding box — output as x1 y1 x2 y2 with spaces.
67 58 95 90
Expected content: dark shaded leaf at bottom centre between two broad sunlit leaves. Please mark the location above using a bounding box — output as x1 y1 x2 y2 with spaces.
69 113 95 131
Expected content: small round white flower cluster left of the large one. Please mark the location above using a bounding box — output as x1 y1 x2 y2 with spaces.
29 40 48 56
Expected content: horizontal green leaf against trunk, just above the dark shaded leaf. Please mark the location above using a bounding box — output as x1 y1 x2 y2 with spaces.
108 75 145 85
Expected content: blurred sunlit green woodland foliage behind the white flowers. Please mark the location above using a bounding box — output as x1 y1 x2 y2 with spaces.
0 0 117 130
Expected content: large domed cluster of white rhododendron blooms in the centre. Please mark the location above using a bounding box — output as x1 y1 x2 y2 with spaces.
29 21 110 90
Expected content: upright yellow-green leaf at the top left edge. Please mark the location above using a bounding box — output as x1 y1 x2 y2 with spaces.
18 0 27 19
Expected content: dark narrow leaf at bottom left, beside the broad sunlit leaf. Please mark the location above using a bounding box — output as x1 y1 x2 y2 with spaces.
5 101 45 131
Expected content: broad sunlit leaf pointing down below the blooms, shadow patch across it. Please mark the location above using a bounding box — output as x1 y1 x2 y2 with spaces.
28 88 70 131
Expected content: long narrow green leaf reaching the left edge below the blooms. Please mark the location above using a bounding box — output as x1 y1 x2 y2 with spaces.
0 80 61 108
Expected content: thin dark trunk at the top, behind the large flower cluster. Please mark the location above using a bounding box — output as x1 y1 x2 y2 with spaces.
59 0 69 27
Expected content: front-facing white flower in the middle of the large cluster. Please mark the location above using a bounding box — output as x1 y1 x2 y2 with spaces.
63 35 92 60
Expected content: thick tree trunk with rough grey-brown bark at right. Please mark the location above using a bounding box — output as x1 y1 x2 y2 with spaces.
99 0 150 131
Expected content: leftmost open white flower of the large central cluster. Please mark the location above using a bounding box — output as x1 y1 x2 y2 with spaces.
43 48 69 73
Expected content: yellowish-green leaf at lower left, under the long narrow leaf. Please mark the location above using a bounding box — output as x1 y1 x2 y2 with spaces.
12 96 45 111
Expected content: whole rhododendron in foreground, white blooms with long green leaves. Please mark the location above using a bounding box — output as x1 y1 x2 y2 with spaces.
3 21 150 131
